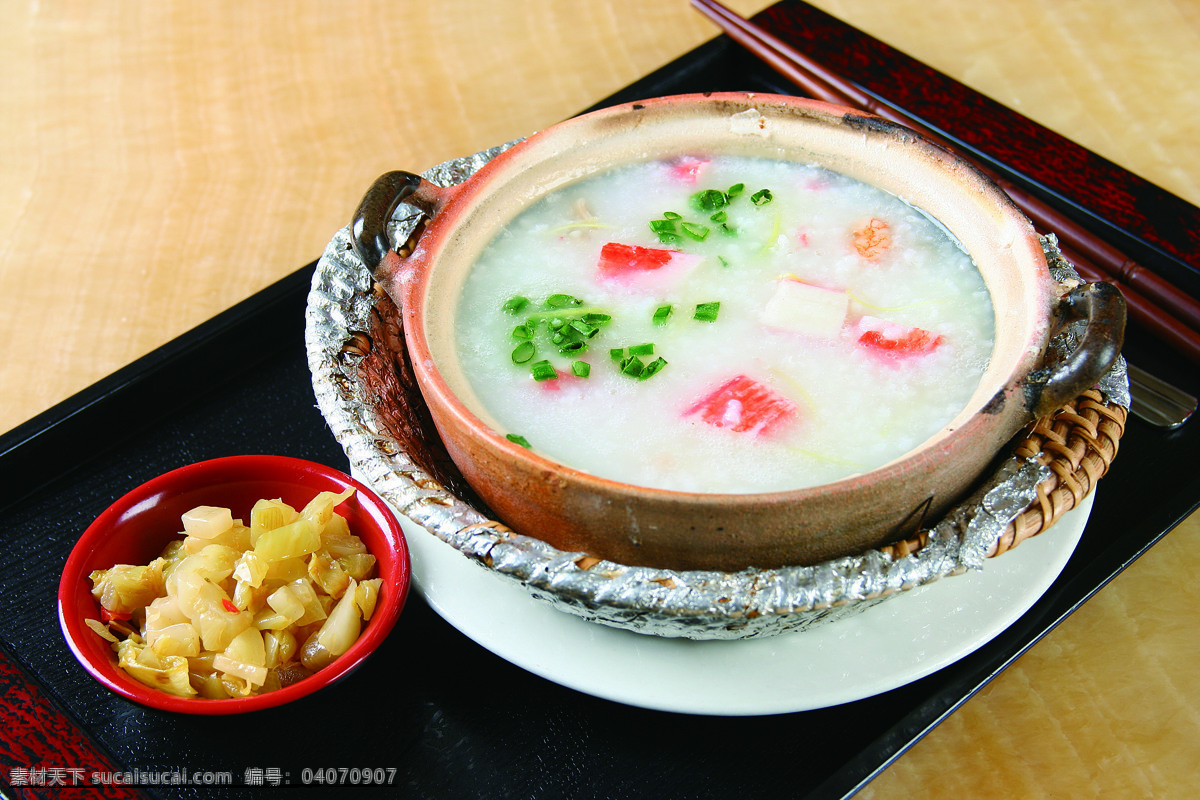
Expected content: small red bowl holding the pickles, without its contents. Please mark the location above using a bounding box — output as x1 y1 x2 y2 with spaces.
59 456 410 714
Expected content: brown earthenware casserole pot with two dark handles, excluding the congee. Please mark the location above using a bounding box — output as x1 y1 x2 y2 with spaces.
350 94 1124 571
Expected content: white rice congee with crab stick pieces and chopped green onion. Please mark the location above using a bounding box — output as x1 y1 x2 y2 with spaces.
456 155 994 493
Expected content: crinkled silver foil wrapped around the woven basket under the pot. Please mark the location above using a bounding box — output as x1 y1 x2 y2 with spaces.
306 143 1129 639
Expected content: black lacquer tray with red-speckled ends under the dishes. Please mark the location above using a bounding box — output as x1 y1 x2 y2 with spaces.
0 2 1200 800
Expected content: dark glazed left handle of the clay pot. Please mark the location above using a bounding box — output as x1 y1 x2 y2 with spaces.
350 170 452 287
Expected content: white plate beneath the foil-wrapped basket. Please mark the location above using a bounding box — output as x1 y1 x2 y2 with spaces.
401 493 1094 716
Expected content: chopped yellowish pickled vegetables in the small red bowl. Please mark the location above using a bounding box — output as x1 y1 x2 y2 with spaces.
86 489 383 699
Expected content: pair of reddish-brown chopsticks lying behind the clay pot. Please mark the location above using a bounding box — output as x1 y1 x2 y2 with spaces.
691 0 1200 365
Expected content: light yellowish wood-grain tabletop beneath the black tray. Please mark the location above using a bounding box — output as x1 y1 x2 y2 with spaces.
0 0 1200 799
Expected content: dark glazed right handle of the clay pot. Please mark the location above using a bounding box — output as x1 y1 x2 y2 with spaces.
1030 282 1126 419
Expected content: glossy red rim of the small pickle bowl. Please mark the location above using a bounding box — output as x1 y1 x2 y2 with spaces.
56 453 412 715
